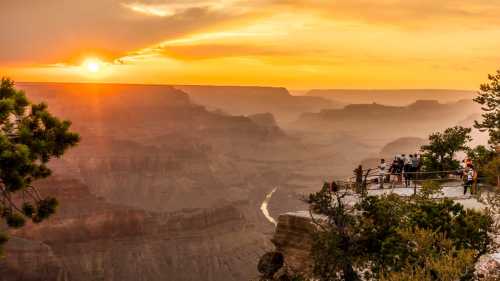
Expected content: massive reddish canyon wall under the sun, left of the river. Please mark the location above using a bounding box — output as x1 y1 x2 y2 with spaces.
6 84 287 281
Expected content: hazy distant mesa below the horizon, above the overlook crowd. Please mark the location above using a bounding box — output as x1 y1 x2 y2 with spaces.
292 100 480 142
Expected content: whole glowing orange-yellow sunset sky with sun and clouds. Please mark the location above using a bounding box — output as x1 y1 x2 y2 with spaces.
0 0 500 89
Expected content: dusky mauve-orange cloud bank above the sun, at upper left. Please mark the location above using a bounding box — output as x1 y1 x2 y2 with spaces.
0 0 248 64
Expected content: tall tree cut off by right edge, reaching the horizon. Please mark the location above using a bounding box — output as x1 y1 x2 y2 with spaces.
474 70 500 146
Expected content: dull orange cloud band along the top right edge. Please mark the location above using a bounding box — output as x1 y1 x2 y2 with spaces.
273 0 500 29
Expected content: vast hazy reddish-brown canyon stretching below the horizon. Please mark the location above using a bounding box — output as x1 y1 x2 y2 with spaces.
0 83 486 281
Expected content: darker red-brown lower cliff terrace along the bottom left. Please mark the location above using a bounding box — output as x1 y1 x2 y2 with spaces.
6 178 269 281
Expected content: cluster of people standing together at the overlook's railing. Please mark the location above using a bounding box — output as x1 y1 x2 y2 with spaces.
378 153 422 188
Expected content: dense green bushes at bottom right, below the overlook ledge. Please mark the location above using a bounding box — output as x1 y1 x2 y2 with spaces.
309 180 492 281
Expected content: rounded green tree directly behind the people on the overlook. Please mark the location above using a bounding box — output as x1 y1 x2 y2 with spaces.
421 126 472 171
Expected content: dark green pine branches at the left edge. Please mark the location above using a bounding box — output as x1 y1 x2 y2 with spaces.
0 78 79 254
